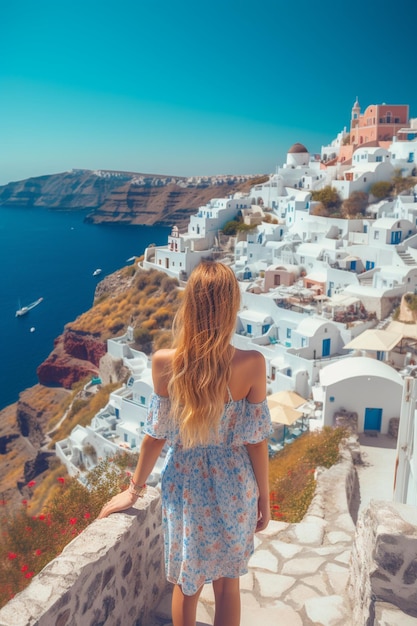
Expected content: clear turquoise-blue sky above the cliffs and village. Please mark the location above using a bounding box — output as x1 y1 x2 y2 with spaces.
0 0 417 184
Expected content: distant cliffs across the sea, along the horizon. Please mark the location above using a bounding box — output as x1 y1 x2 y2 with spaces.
0 170 259 226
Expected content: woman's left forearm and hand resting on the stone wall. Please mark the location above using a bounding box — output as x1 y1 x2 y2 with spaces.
98 435 165 519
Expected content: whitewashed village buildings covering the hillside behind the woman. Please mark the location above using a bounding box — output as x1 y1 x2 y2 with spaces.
56 100 417 506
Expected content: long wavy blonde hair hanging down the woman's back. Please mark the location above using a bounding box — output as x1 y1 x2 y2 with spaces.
168 261 240 447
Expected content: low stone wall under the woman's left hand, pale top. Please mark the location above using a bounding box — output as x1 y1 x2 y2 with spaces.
0 487 167 626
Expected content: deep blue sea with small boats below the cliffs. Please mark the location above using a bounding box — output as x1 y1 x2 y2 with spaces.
0 207 170 409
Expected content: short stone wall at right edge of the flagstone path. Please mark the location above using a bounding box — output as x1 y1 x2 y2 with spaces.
348 501 417 626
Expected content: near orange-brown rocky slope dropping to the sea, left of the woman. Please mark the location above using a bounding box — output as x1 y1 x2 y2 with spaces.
0 265 179 506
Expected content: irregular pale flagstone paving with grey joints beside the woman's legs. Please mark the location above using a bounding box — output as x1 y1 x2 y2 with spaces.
157 518 353 626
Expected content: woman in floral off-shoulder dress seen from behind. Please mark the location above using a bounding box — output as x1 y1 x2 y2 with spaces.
99 262 271 626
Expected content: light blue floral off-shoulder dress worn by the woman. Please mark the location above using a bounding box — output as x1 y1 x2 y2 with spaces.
145 392 271 595
